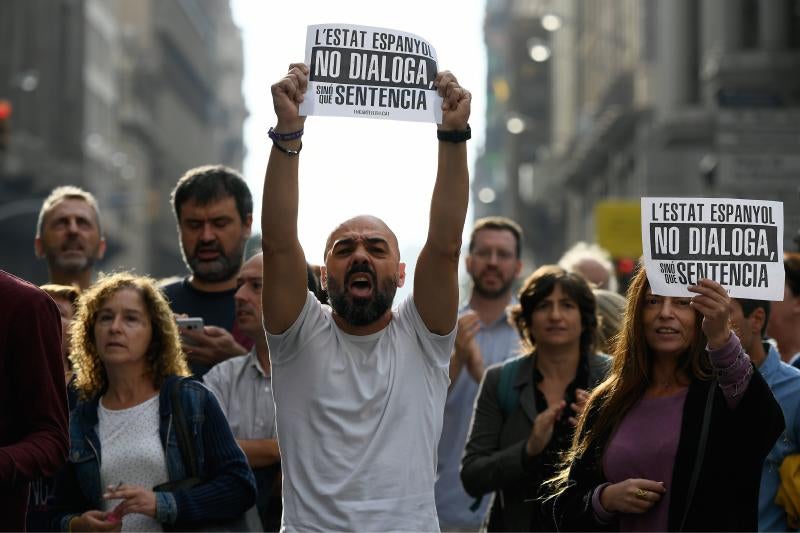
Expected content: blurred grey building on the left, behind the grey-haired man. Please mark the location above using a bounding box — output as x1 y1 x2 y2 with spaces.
0 0 247 283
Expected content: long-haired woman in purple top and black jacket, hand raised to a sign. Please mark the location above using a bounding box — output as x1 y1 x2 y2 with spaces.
544 268 784 531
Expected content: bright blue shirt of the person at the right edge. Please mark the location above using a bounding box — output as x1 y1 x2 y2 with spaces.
758 343 800 531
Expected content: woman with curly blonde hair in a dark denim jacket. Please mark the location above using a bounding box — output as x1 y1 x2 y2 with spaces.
56 273 255 531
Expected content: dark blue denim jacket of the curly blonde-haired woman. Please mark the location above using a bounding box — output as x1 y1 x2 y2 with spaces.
54 376 256 531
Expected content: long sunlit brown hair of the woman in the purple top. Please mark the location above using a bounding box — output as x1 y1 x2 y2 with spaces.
548 267 711 495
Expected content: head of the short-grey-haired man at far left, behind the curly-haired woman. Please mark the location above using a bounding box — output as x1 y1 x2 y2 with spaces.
33 185 106 289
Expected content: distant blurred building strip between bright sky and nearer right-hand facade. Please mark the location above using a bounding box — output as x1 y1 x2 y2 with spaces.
472 0 552 264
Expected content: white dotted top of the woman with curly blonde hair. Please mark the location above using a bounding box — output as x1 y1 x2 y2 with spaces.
97 394 167 531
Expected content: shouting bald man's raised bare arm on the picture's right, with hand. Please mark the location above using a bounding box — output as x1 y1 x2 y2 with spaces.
414 71 472 335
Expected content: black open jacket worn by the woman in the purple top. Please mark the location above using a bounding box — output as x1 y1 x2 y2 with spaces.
545 371 784 531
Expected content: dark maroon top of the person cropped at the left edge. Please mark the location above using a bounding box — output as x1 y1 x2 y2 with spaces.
0 270 69 531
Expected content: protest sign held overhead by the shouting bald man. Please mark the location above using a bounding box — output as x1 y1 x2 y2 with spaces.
300 24 442 123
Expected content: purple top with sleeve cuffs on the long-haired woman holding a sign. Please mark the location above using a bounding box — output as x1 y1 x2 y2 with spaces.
592 332 753 531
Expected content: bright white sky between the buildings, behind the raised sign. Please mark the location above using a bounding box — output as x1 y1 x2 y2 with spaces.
232 0 486 300
